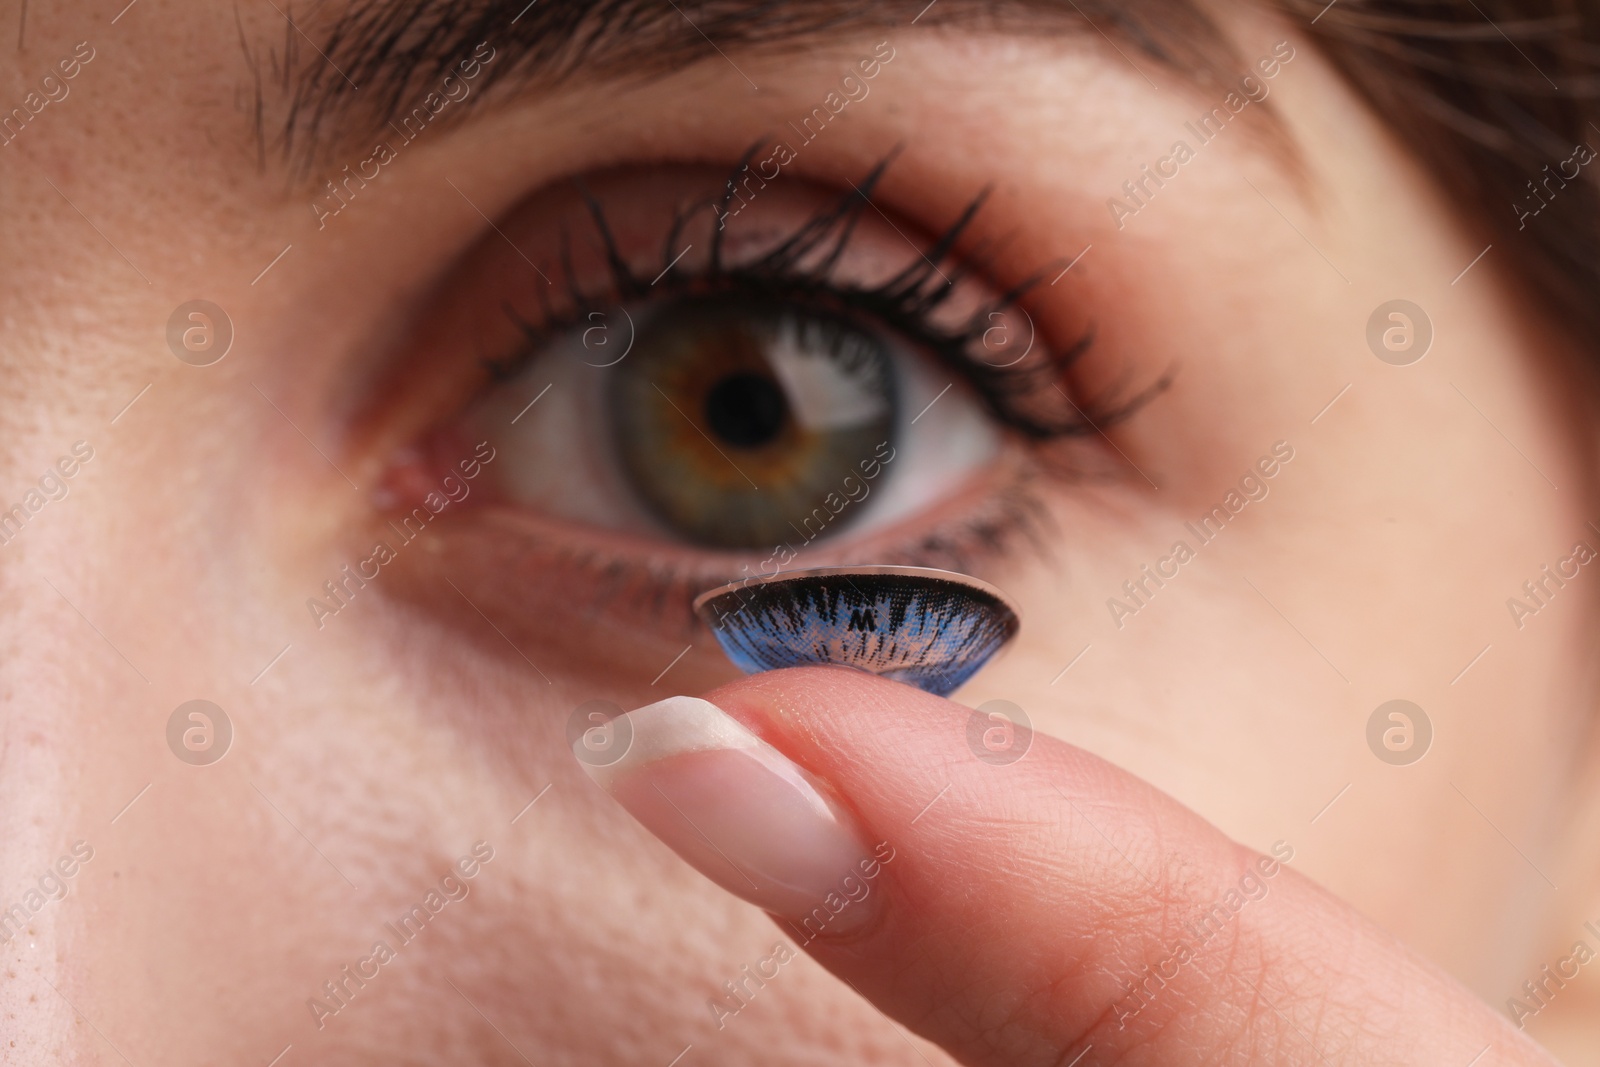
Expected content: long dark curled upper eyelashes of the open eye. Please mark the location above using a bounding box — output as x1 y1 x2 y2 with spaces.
486 142 1168 442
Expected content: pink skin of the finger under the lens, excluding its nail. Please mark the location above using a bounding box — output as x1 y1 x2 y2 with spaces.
697 667 1574 1065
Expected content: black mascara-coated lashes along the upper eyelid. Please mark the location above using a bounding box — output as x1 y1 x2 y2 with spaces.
486 146 1154 442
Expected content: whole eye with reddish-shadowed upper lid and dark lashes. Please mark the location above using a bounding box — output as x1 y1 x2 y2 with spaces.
376 154 1139 616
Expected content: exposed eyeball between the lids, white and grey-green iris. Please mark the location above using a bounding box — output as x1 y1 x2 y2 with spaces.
467 293 1002 550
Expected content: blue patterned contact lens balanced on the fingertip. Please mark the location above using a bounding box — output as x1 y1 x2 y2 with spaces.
694 566 1019 696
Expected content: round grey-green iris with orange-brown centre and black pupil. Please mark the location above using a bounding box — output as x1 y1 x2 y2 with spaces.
608 298 896 549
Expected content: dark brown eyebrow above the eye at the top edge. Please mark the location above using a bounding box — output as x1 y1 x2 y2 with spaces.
259 0 1237 176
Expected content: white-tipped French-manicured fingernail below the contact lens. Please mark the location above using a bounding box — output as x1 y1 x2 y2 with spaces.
573 696 882 939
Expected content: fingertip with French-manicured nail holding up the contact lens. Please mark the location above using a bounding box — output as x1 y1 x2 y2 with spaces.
589 669 1554 1067
